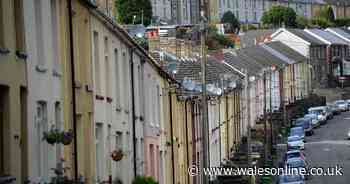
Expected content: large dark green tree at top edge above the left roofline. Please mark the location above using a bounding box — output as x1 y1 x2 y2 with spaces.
115 0 152 26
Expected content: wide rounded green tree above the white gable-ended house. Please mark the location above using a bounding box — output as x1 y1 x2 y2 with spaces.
261 6 297 27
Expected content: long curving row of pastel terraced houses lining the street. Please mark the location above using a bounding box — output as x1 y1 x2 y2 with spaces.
0 0 350 184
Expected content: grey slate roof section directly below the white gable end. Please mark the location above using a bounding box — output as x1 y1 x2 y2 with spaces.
264 41 307 62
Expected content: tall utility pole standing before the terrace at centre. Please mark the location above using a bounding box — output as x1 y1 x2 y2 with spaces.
200 9 209 184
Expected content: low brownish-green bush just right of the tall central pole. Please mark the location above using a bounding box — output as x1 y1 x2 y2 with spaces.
206 26 235 50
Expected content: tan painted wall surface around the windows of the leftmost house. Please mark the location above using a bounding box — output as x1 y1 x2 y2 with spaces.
0 0 27 184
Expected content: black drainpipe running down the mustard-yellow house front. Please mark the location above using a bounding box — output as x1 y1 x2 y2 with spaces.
67 0 78 181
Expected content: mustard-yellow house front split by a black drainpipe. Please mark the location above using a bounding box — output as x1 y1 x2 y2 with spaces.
59 1 95 183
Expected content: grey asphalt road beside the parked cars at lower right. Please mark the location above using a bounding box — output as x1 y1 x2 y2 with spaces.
305 112 350 184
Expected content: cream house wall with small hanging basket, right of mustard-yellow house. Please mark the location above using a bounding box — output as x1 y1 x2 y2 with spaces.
91 18 144 183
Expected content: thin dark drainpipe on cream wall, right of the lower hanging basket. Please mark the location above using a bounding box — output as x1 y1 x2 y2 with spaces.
129 48 137 177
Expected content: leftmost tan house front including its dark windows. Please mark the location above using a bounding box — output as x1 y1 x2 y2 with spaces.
0 0 29 184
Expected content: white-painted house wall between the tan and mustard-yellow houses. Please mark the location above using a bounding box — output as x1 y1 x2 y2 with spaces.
23 0 63 182
